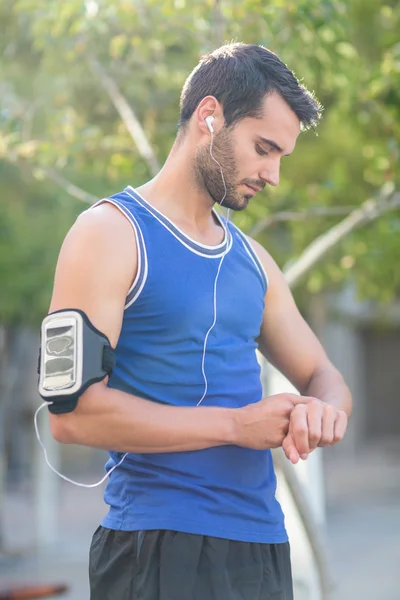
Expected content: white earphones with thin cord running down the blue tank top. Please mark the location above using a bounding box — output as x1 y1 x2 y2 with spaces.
33 115 230 488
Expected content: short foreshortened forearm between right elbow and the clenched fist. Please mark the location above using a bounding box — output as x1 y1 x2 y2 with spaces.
303 367 352 417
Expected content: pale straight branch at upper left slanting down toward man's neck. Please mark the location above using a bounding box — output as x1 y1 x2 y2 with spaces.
88 57 160 175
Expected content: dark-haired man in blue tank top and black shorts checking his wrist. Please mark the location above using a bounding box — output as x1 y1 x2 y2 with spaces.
50 44 351 600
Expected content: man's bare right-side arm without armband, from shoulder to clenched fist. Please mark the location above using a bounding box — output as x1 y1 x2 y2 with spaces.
250 240 352 462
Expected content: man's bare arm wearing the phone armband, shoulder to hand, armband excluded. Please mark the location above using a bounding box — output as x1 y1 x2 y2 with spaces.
50 204 308 453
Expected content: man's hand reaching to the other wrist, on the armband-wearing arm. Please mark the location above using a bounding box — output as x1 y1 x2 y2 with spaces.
234 394 318 450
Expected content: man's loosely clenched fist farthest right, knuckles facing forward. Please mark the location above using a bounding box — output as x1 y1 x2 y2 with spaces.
282 399 347 464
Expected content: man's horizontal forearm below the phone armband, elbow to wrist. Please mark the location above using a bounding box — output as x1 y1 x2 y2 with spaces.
51 383 235 453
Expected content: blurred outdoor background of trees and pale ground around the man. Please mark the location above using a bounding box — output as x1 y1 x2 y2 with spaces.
0 0 400 600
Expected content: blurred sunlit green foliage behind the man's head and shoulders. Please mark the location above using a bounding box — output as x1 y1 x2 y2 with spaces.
0 0 400 322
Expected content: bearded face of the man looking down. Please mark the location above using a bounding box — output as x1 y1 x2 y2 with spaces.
194 94 300 210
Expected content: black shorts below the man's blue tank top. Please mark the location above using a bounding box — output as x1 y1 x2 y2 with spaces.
89 527 293 600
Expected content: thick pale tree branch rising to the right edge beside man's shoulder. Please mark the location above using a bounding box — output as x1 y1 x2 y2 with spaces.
283 190 400 288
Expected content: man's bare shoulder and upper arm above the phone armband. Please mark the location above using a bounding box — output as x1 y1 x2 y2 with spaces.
50 203 137 342
